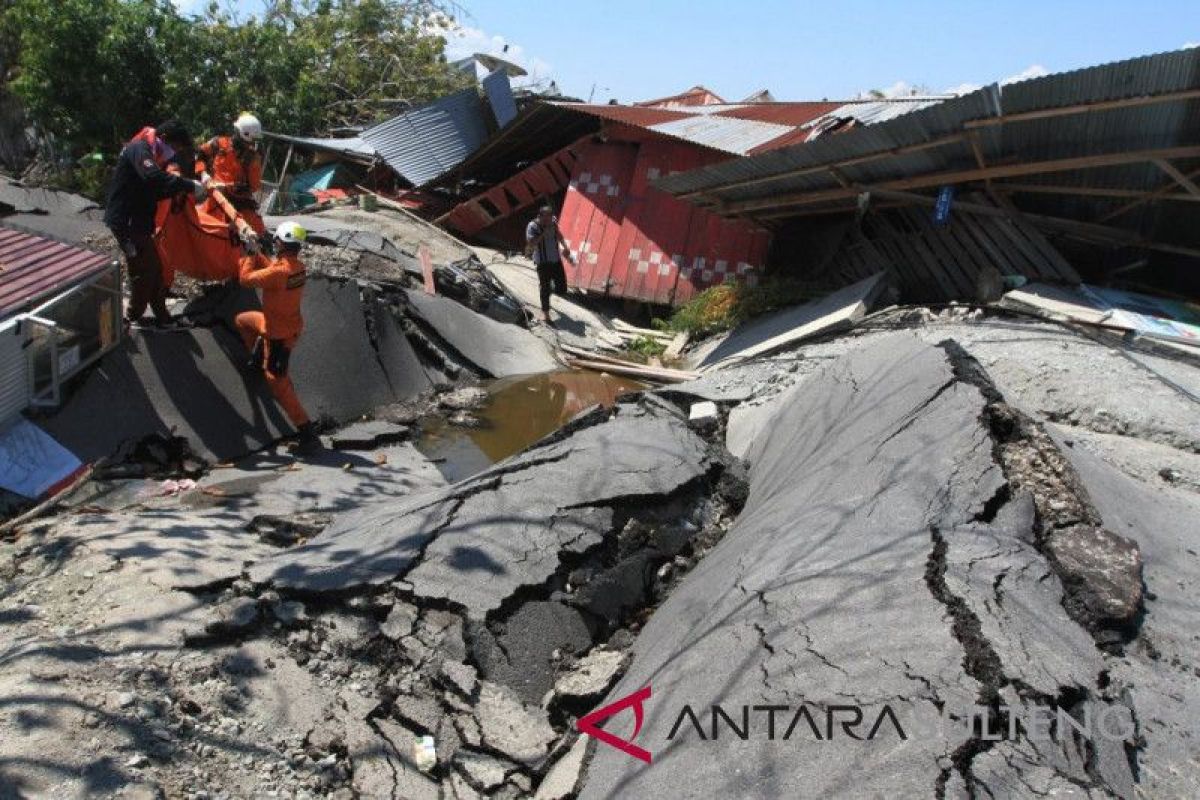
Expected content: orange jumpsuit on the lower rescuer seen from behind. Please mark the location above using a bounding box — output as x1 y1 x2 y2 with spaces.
234 252 308 428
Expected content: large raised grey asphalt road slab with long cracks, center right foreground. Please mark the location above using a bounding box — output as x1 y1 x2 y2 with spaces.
581 336 1123 798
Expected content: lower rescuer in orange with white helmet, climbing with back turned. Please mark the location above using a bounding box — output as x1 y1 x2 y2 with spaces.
234 221 320 456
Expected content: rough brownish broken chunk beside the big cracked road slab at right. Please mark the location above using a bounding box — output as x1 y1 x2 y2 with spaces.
1046 525 1142 632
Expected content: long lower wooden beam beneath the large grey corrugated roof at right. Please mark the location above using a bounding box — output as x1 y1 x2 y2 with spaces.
718 145 1200 215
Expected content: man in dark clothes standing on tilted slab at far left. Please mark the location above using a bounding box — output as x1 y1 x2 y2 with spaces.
104 120 205 330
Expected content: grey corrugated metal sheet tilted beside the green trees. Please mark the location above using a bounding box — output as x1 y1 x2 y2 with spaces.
362 88 488 186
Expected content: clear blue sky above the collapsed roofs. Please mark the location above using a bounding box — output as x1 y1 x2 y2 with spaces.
178 0 1200 102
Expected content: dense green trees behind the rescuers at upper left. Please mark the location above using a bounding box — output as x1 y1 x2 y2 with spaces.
0 0 470 155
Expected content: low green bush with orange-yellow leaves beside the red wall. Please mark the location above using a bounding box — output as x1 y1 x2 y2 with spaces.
655 278 824 336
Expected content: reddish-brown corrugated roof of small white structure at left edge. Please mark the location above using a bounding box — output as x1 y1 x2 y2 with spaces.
0 225 113 318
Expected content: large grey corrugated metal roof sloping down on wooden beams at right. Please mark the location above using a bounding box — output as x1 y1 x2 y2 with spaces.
656 49 1200 224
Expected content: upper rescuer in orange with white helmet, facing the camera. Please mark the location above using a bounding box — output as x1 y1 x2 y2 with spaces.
196 113 266 236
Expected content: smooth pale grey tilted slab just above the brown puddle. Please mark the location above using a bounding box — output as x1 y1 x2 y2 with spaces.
406 289 560 378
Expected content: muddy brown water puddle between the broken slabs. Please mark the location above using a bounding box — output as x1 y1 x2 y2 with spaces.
416 369 644 481
